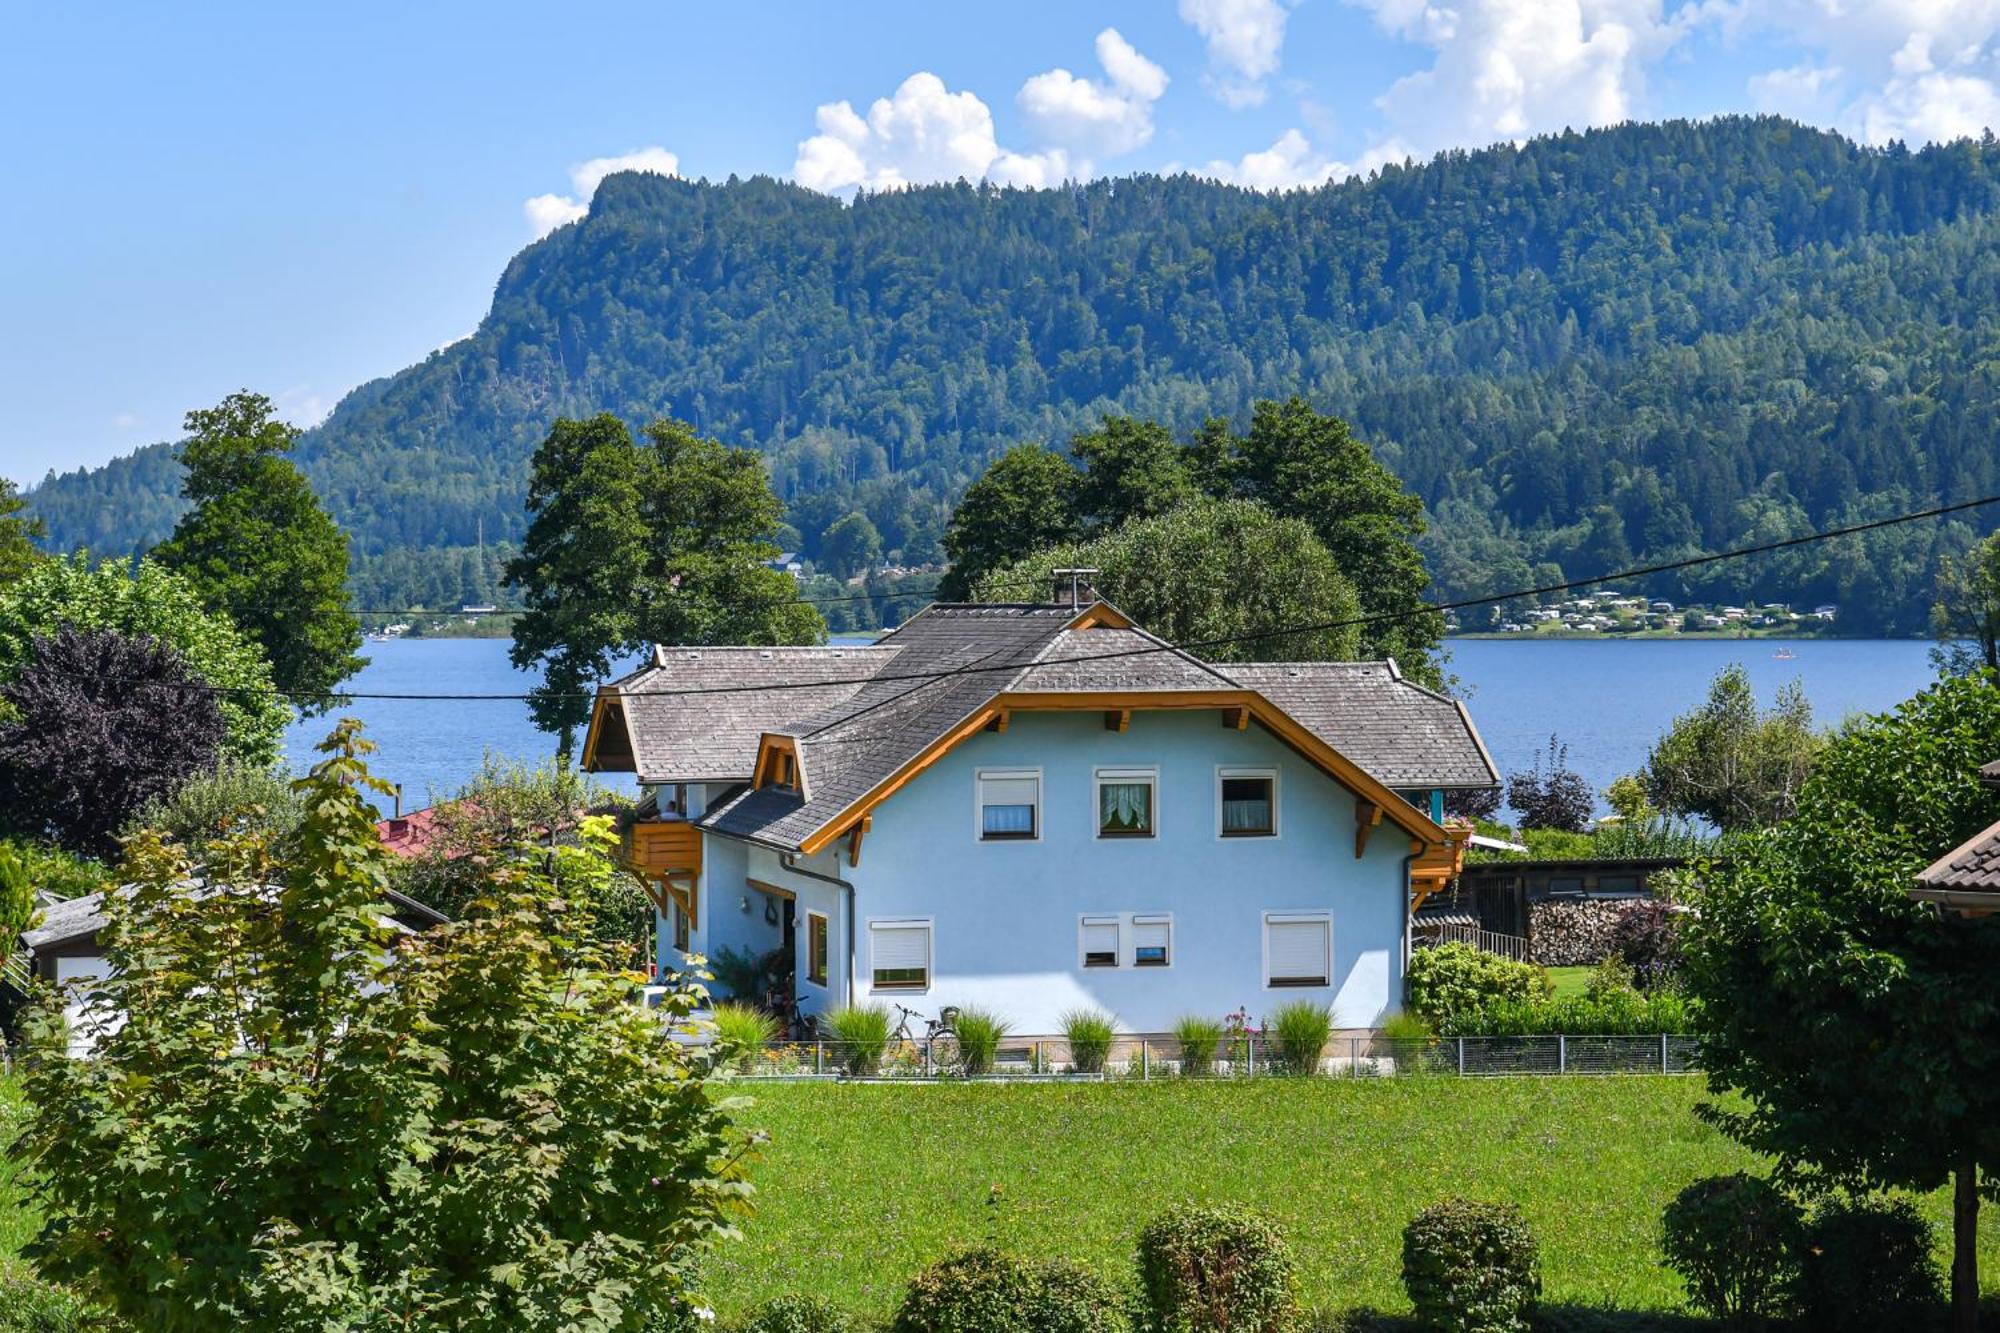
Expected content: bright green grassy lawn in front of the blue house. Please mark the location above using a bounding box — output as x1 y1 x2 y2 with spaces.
708 1077 2000 1329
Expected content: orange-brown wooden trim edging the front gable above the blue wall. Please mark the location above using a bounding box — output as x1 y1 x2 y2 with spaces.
798 691 1458 859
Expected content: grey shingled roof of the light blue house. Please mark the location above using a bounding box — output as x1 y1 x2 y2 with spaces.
586 602 1498 847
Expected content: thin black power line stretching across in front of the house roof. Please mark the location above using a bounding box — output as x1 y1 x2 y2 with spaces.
62 482 2000 703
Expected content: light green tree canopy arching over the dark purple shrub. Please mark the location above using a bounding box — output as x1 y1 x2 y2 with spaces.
0 554 292 765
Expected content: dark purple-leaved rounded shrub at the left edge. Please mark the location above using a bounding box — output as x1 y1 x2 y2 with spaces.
0 626 224 855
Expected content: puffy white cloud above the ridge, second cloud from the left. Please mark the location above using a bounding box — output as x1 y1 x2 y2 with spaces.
792 70 1000 194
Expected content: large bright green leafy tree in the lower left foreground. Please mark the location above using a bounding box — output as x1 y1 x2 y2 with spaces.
28 721 748 1333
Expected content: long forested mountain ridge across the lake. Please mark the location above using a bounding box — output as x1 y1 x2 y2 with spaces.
32 118 2000 630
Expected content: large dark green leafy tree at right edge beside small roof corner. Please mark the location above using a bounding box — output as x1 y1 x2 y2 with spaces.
1684 677 2000 1331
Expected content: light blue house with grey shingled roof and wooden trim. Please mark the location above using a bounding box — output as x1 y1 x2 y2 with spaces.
584 602 1496 1035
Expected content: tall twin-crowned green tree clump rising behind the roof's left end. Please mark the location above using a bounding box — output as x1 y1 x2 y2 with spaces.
508 412 826 757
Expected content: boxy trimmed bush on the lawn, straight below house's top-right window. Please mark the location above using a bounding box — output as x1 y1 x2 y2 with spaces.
1138 1205 1298 1333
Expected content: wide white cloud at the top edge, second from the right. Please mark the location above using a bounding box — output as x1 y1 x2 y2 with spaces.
1348 0 1708 152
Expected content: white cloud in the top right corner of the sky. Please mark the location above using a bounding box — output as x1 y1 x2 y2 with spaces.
1730 0 2000 144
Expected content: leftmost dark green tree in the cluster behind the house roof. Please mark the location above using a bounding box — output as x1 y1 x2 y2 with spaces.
938 444 1082 600
